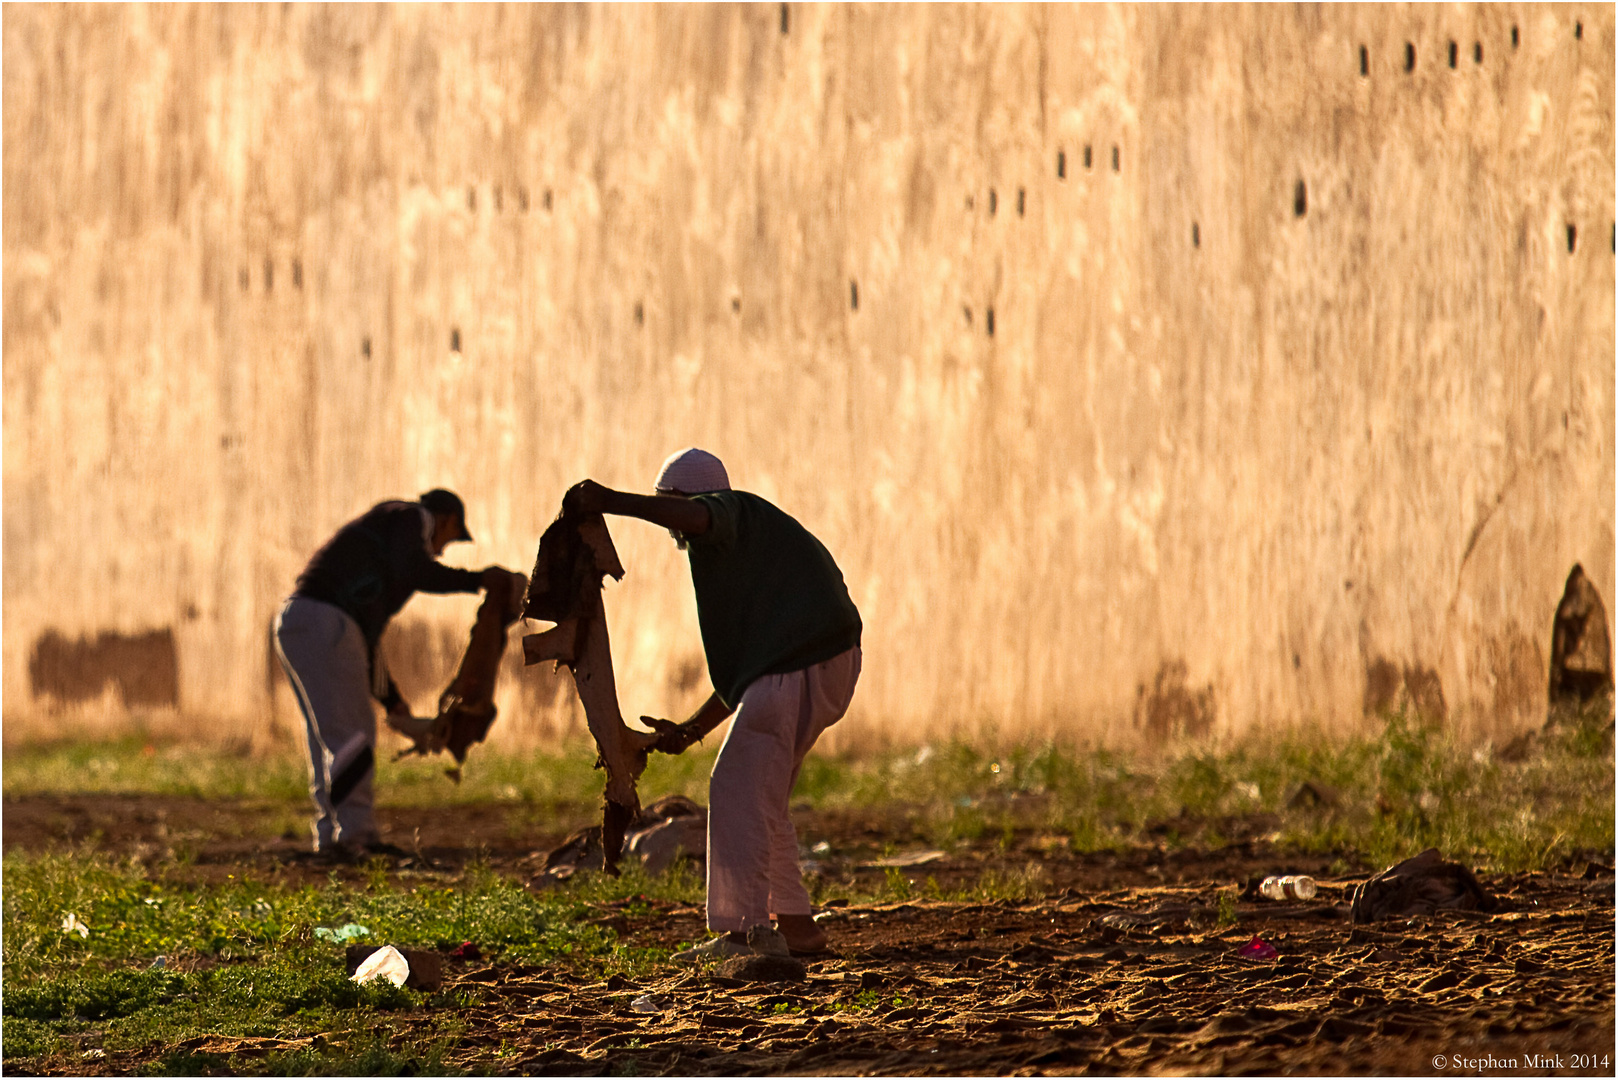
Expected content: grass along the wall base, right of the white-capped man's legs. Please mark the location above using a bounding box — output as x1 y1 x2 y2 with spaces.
794 706 1613 871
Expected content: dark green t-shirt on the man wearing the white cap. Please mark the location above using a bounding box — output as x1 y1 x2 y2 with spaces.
686 491 861 708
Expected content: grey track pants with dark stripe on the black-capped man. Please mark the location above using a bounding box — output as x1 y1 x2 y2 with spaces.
275 596 377 850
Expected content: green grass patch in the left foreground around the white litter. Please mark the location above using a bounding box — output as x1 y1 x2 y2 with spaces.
0 855 701 1075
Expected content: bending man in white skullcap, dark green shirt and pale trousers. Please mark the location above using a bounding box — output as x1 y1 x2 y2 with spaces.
570 449 861 960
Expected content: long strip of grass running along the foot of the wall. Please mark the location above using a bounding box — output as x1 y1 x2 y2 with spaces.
3 701 1613 871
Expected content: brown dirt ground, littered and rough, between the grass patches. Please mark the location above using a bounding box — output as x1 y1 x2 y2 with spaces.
3 797 1615 1077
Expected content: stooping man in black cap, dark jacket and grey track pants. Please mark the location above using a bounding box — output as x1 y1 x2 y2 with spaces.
275 487 503 855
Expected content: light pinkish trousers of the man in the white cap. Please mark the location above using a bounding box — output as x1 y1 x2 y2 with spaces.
707 646 861 933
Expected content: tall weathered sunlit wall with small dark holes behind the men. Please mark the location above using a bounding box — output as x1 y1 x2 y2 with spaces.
3 3 1615 742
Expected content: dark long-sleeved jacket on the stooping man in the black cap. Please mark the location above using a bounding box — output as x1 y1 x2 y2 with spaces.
293 502 482 704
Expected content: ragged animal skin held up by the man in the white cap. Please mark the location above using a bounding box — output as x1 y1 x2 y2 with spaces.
523 504 659 873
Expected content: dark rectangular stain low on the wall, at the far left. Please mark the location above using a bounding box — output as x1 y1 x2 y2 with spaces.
28 627 180 708
